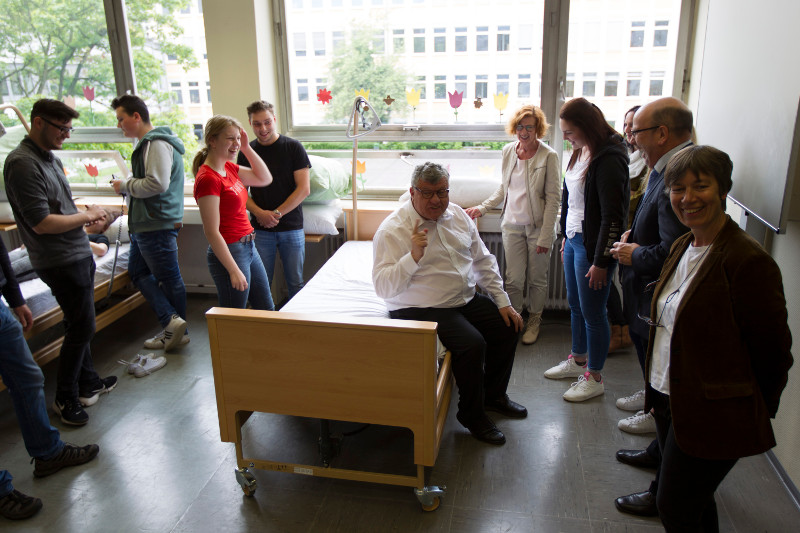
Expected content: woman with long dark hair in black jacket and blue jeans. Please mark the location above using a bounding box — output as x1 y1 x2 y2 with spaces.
544 98 630 402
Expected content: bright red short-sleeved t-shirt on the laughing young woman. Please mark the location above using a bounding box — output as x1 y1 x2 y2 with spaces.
194 161 253 244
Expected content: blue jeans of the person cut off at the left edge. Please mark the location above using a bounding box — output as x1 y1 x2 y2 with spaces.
0 302 64 497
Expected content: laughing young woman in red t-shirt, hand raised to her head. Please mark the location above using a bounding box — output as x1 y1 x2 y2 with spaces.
192 115 275 310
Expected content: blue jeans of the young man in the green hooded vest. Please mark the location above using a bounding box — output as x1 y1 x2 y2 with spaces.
128 229 186 328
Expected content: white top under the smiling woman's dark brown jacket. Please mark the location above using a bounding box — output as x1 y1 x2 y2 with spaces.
650 245 711 394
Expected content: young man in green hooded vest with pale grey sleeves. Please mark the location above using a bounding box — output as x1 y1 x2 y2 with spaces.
111 94 189 362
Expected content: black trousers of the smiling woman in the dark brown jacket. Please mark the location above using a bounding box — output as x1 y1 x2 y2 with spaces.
653 391 737 533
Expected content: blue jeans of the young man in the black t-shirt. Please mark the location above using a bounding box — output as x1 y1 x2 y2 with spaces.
256 229 306 299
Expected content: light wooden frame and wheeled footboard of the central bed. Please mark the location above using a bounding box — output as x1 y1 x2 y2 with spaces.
206 307 453 511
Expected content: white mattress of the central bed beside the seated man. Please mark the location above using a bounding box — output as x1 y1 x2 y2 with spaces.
281 241 389 318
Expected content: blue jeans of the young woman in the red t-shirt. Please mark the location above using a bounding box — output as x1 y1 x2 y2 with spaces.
208 241 275 311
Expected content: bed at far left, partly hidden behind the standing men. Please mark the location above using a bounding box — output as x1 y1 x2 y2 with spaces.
0 243 145 390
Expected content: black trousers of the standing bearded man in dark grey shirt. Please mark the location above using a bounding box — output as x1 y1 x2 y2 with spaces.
36 256 102 401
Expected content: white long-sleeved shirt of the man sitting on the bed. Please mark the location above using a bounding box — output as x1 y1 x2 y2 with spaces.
372 201 511 311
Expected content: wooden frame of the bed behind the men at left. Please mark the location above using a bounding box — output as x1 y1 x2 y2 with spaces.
0 270 145 391
